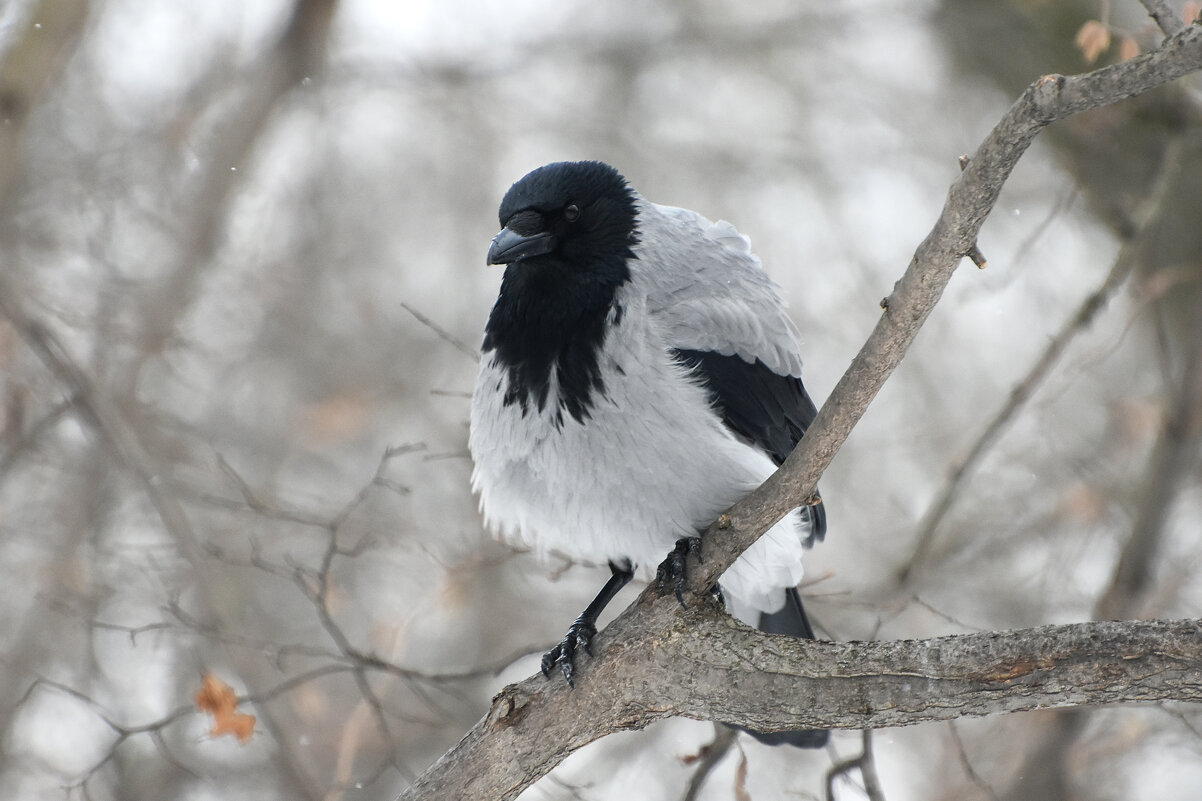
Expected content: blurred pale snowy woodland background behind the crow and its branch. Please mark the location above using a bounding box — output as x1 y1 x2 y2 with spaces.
0 0 1202 801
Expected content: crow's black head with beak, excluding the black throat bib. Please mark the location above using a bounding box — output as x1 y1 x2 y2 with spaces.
488 161 638 273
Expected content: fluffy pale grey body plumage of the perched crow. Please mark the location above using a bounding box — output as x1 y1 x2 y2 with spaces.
470 190 810 612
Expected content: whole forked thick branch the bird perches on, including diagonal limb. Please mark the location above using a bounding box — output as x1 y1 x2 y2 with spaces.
401 18 1202 800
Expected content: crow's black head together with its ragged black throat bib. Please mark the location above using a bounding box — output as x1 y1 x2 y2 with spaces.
483 161 638 422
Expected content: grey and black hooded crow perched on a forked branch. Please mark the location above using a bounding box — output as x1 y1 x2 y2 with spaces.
469 161 827 747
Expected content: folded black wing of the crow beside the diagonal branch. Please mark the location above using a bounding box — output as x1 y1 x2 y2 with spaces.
673 350 826 545
